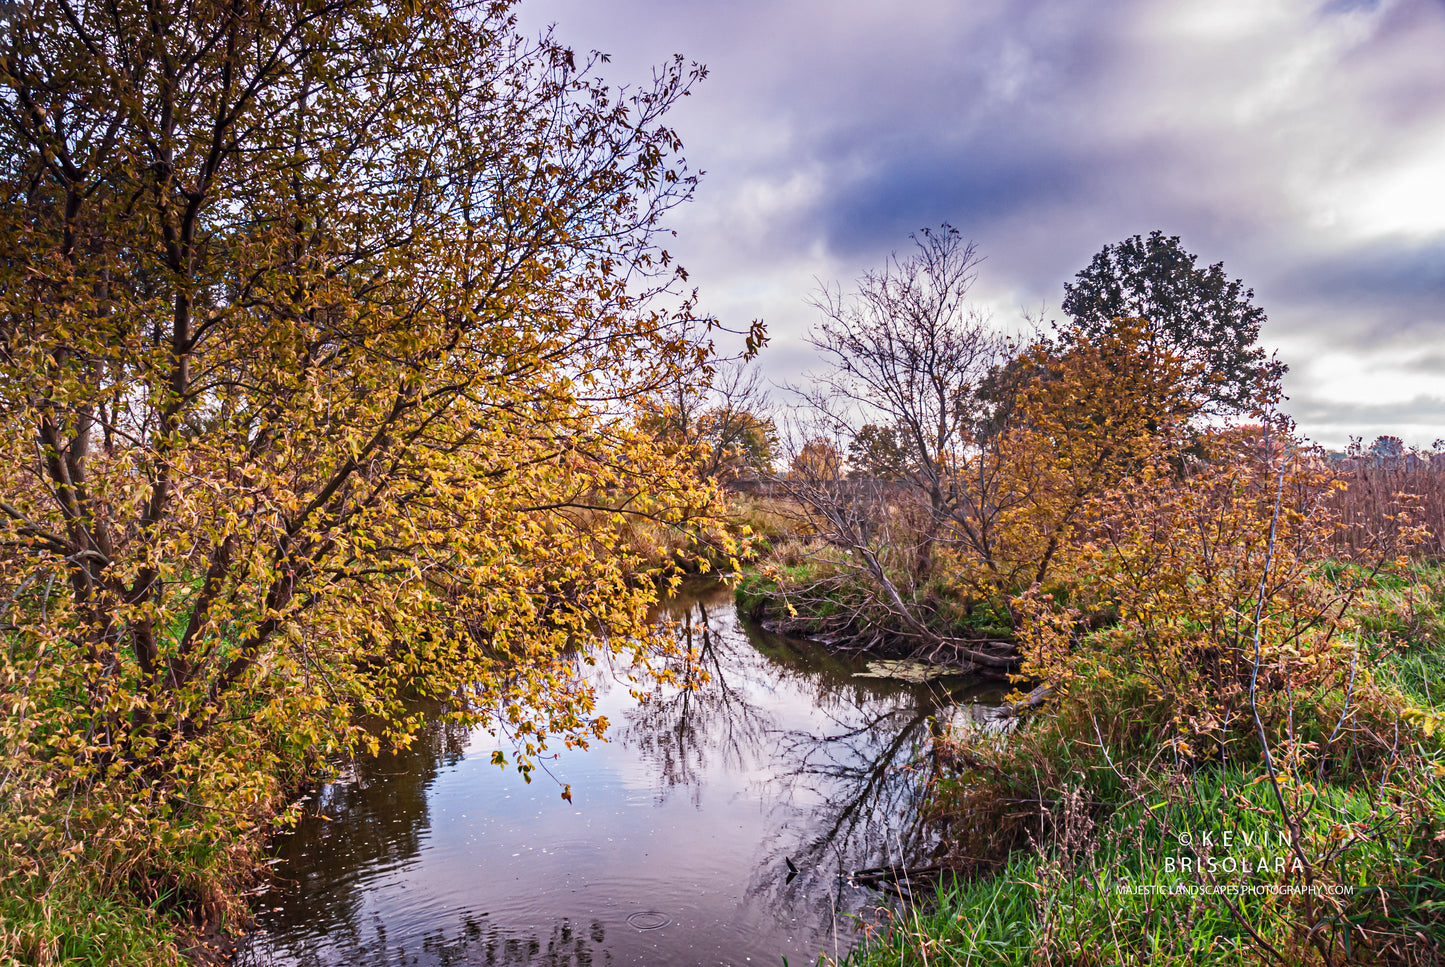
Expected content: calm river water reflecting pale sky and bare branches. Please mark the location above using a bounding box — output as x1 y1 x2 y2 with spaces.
237 584 999 967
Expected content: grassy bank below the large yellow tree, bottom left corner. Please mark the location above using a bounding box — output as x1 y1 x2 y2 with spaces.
0 682 304 967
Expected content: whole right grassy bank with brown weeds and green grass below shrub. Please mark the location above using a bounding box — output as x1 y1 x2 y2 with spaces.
845 564 1445 967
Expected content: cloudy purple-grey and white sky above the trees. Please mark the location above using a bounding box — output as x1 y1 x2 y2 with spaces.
522 0 1445 447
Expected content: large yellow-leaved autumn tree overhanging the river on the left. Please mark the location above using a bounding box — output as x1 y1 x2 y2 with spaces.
0 0 739 835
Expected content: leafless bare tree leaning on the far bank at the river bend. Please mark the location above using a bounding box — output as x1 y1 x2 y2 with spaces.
786 224 1012 671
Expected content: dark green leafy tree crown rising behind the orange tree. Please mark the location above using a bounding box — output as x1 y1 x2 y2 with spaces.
1062 230 1286 415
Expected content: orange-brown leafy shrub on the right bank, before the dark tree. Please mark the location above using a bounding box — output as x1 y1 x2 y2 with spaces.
1020 428 1418 762
